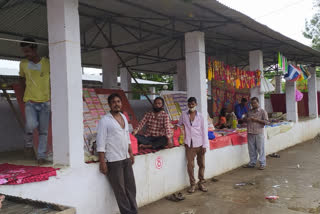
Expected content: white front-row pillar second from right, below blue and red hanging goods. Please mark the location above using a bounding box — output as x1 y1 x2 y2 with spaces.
286 81 298 122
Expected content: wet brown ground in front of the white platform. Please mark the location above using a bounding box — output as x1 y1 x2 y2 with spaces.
139 140 320 214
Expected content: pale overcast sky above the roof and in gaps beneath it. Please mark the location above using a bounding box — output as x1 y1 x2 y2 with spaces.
0 0 314 74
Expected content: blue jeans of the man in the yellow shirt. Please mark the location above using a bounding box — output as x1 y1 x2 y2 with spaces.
24 102 50 159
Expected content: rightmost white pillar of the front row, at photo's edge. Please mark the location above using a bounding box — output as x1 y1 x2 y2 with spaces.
308 67 318 118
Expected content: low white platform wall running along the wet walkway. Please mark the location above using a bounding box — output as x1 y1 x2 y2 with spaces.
0 119 320 214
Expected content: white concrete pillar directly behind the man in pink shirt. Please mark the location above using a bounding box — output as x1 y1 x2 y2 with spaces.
185 31 208 118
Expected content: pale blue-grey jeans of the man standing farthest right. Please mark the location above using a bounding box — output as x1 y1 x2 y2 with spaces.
248 133 266 166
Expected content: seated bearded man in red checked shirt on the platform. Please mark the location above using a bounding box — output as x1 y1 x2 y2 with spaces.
132 97 172 149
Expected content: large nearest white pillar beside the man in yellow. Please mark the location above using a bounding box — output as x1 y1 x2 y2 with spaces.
47 0 84 167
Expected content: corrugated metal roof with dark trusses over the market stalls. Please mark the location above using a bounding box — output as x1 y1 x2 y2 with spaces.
0 0 320 73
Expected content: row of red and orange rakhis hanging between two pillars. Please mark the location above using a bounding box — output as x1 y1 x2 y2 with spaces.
207 57 261 89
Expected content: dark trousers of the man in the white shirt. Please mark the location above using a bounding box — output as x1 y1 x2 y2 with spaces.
107 159 138 214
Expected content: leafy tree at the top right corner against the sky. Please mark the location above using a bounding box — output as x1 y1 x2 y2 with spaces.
303 0 320 51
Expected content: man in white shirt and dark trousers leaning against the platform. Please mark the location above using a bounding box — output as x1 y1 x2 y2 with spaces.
97 94 138 214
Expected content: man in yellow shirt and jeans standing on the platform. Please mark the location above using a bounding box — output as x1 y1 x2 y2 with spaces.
19 38 50 165
